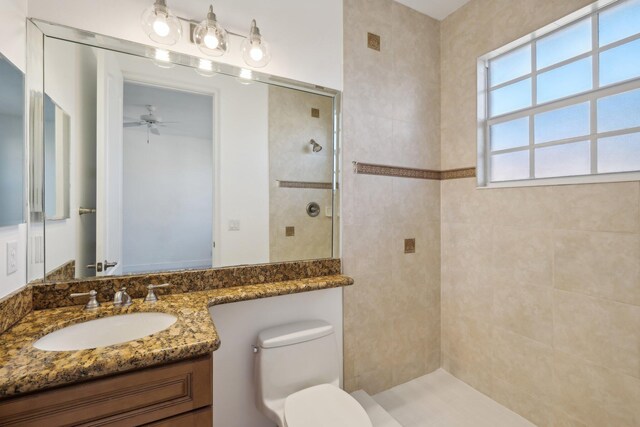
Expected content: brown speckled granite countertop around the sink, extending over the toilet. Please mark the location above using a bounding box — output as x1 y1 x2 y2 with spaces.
0 275 353 399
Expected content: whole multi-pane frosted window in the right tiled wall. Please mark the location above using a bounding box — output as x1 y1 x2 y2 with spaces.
479 0 640 184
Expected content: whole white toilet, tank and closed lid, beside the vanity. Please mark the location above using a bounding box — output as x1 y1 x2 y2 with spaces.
255 320 372 427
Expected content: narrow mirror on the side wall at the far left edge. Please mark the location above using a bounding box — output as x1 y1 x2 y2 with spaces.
0 55 24 227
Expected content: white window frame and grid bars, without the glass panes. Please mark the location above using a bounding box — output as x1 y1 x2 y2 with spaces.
476 0 640 188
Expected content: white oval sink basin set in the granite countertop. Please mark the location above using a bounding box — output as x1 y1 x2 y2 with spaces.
33 313 178 351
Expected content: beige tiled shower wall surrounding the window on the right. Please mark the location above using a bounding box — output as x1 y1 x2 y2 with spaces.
441 0 640 426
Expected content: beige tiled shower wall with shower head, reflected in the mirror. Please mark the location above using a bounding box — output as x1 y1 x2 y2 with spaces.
269 86 333 262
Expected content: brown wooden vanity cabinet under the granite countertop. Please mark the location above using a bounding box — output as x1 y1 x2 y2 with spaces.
0 355 213 427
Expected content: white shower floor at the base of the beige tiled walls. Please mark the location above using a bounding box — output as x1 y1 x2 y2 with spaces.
373 369 535 427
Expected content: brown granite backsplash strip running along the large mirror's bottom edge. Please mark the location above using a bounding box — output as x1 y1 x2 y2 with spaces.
31 258 341 310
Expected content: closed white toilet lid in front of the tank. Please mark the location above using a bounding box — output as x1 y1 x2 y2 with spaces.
284 384 372 427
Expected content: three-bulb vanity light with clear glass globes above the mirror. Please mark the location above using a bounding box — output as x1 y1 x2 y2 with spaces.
142 0 271 68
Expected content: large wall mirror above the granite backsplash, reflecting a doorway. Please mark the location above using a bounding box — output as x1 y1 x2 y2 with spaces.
31 22 338 282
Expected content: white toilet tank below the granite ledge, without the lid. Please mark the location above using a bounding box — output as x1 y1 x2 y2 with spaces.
254 320 340 425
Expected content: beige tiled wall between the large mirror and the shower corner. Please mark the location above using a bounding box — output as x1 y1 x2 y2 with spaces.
341 0 440 393
